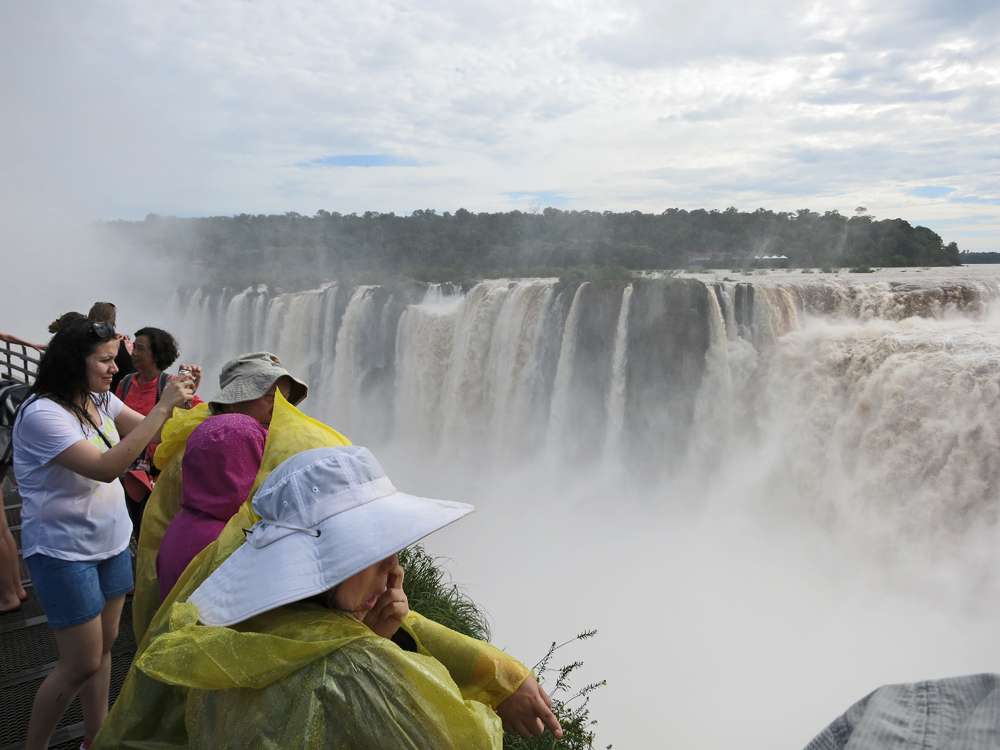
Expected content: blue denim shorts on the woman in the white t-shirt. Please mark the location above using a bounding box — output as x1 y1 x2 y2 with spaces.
24 548 134 630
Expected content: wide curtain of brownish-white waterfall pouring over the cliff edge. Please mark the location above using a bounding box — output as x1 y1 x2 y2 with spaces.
168 278 1000 548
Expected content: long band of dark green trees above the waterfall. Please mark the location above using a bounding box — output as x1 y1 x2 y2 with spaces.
106 206 962 283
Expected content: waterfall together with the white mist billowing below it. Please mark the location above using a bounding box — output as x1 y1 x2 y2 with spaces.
166 269 1000 749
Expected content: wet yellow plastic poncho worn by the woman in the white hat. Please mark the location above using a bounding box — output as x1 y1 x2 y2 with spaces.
133 603 502 750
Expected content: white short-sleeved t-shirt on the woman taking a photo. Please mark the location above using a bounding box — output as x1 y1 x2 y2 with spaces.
14 393 132 560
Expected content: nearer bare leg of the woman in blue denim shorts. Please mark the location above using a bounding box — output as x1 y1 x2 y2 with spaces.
24 616 106 750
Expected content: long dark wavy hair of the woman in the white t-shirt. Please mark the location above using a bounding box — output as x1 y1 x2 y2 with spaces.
29 318 115 422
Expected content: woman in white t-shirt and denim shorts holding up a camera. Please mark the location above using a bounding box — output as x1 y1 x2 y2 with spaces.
14 318 193 750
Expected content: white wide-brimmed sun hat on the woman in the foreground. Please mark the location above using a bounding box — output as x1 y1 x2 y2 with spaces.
189 445 475 625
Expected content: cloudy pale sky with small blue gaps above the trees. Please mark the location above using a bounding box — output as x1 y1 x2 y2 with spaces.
0 0 1000 251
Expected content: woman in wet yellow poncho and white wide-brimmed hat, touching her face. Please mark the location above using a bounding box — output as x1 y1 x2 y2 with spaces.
177 446 560 749
